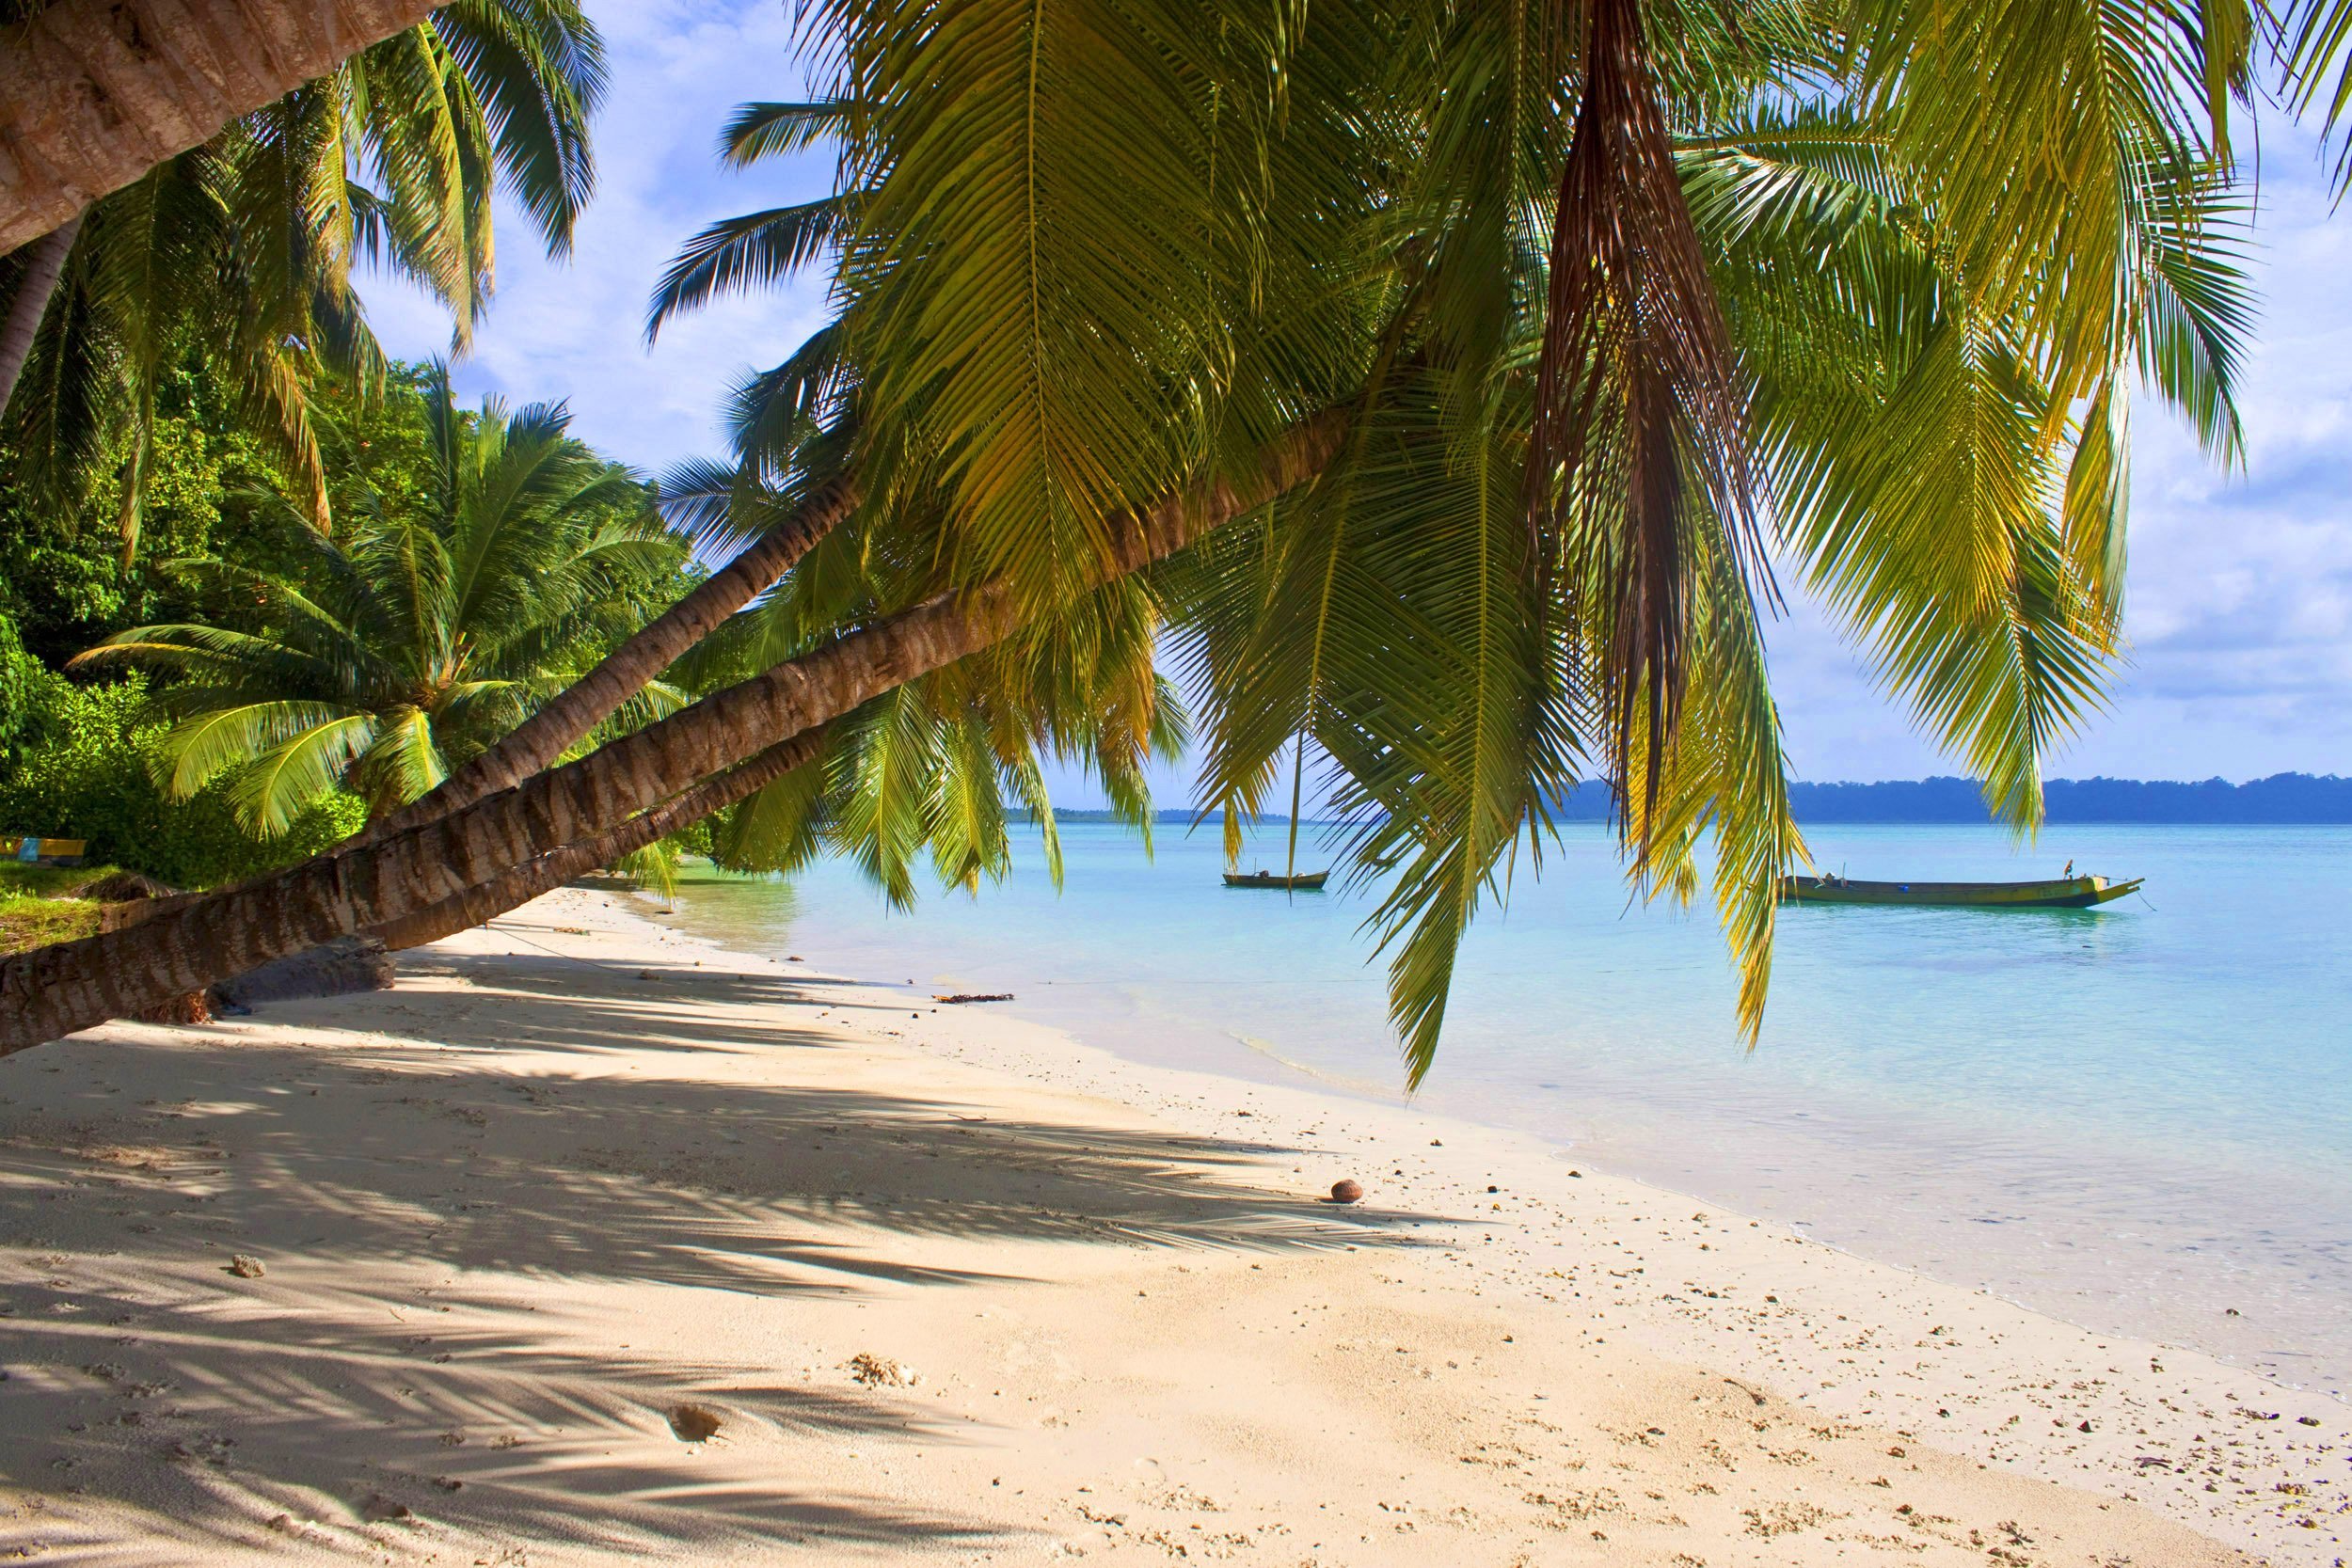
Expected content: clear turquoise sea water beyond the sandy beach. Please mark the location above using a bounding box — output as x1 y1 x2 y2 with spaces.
659 825 2352 1394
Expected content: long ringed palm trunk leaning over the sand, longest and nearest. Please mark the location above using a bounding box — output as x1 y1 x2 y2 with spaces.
0 409 1348 1055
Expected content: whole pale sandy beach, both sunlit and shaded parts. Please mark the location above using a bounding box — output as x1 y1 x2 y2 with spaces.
0 889 2352 1568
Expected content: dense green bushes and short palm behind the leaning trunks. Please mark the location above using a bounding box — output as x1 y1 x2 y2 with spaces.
0 367 696 886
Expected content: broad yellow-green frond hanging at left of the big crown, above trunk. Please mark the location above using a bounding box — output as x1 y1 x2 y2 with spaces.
818 0 1232 609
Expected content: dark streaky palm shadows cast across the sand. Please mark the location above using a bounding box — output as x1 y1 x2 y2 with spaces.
0 955 1425 1563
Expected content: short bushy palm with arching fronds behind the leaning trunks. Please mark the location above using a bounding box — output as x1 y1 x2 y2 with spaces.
75 367 685 837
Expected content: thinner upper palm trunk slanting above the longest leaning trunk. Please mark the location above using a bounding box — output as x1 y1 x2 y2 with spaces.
362 480 859 853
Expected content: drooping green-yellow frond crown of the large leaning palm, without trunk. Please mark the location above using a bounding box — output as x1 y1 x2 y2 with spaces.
597 5 2247 1069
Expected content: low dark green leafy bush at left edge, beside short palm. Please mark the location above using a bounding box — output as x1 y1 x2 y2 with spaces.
0 670 367 886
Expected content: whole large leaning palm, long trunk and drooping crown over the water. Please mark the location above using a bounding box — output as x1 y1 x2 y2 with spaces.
0 0 2314 1074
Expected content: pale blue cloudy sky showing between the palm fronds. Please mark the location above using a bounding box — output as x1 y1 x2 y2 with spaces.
370 0 2352 806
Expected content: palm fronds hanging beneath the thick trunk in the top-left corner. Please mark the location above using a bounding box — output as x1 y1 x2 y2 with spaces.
0 0 605 562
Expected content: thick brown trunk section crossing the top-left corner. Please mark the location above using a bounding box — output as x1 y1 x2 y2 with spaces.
0 0 437 254
